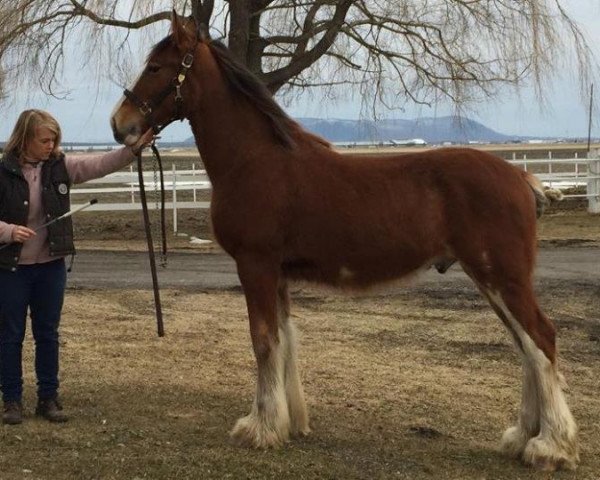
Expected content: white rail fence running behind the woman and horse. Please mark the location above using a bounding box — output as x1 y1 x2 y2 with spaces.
71 151 600 233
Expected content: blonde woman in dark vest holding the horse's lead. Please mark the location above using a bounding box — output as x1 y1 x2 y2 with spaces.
0 110 152 425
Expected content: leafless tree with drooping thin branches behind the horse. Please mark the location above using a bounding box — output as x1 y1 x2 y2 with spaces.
0 0 592 113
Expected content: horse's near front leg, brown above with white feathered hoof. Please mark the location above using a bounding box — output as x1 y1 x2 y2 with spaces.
231 257 290 448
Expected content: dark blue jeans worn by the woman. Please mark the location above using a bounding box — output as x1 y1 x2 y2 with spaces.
0 258 67 402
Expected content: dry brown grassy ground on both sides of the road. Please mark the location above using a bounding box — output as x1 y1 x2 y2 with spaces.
0 202 600 480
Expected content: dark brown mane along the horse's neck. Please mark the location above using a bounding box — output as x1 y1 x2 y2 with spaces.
207 40 301 148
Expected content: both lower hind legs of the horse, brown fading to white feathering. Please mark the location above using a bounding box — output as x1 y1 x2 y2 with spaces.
480 280 579 470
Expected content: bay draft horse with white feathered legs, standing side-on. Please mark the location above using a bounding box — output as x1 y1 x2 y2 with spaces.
111 13 579 470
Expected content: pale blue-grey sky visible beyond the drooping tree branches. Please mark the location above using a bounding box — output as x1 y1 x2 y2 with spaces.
0 0 600 143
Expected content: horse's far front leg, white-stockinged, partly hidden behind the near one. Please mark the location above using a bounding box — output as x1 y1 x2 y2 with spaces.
277 280 310 435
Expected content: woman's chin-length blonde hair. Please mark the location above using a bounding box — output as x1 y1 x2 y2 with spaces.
4 109 62 157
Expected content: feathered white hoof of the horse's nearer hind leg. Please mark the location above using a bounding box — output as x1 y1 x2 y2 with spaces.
523 436 579 472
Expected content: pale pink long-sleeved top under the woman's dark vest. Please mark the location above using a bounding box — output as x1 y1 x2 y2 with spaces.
0 147 135 265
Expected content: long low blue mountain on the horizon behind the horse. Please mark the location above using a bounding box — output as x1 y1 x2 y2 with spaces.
185 116 519 143
